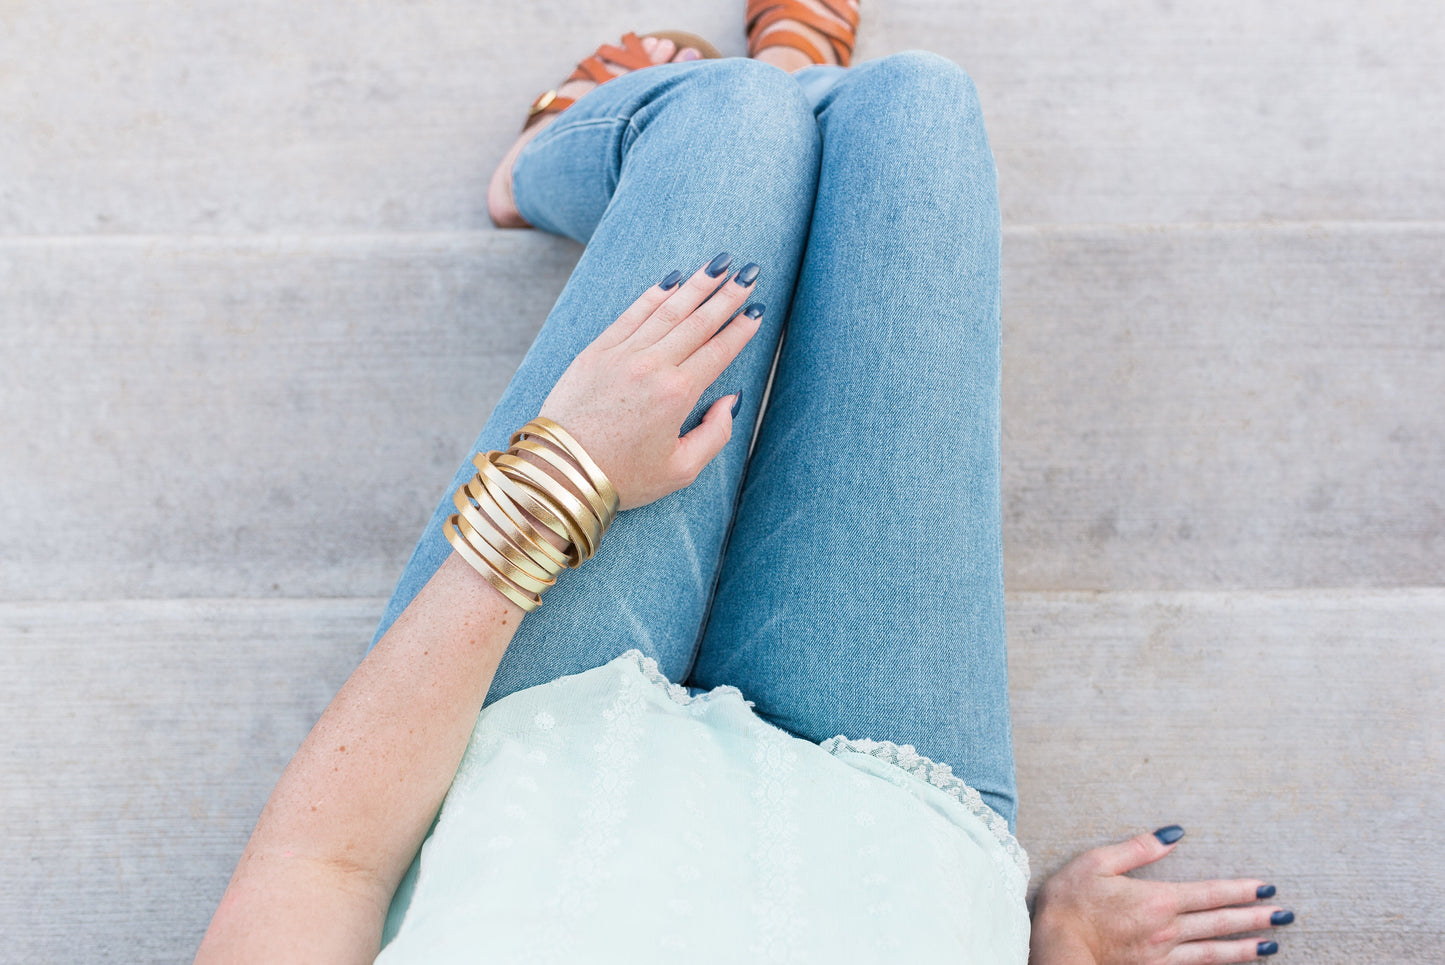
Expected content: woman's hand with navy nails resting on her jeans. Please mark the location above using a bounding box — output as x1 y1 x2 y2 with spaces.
539 254 763 510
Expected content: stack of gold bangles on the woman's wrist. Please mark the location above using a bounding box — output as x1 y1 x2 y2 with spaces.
442 416 620 613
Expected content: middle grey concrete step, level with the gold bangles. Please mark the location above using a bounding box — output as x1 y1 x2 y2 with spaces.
0 225 1445 600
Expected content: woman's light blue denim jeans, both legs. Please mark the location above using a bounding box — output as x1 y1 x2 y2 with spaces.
367 52 1016 930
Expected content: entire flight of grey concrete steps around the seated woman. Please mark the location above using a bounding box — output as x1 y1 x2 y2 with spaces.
0 0 1445 965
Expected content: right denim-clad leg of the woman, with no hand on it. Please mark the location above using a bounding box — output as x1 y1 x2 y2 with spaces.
691 52 1016 826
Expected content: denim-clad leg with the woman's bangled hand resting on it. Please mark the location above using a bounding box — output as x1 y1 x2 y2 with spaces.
367 59 819 704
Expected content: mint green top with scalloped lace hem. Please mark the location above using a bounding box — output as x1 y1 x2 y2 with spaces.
376 650 1029 965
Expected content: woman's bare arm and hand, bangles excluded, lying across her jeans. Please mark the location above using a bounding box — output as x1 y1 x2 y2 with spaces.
197 260 762 964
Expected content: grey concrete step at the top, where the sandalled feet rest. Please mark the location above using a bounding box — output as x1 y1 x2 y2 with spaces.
0 0 1445 235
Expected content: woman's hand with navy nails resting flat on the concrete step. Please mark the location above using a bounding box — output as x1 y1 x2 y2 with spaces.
1029 825 1295 965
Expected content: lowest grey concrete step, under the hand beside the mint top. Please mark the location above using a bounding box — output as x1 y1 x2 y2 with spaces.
0 589 1445 965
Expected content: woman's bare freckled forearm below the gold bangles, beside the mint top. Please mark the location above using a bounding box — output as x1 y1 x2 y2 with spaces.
198 555 522 961
